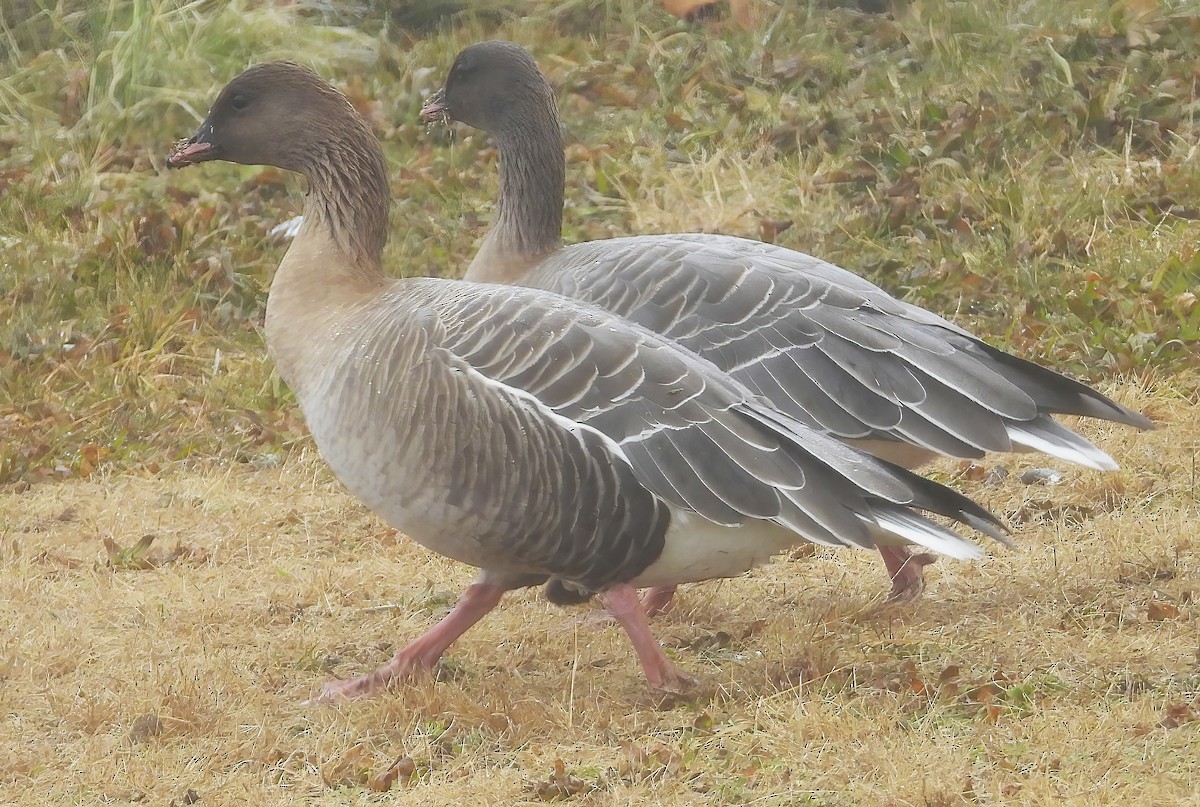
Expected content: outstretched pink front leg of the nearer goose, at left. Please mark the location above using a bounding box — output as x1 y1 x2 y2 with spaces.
316 582 504 704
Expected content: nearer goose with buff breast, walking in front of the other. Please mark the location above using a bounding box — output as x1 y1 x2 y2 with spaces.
167 62 1003 700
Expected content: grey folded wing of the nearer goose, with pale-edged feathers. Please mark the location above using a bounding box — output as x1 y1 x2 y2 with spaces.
422 283 1002 564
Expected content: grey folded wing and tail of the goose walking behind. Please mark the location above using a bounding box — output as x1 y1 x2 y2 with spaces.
540 234 1152 468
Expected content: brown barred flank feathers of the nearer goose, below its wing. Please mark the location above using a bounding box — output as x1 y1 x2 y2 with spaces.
369 296 670 591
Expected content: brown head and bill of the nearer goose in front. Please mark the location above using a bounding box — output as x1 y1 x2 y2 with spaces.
167 61 373 172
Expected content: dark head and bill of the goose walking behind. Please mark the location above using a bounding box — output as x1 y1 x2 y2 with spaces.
421 41 557 133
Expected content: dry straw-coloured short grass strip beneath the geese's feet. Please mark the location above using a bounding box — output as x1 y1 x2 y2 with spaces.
0 377 1200 805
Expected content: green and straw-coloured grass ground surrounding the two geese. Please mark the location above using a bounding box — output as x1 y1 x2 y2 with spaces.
0 0 1200 805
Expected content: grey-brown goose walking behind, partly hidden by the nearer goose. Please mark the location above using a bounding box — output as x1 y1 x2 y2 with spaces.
421 42 1153 609
